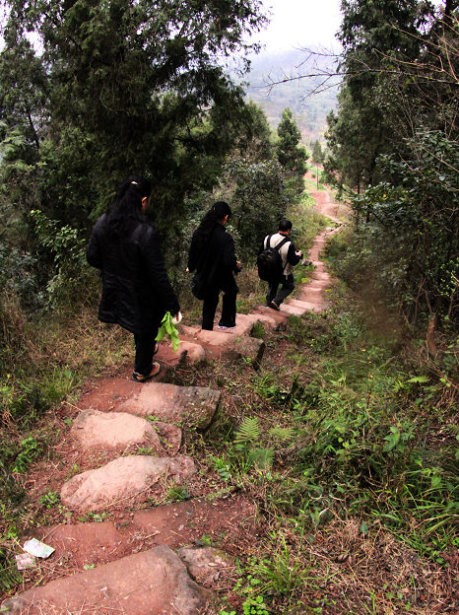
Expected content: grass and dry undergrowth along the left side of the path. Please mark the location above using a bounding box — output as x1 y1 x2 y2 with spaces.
0 308 132 592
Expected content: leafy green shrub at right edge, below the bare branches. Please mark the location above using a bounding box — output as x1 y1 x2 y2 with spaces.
345 131 459 322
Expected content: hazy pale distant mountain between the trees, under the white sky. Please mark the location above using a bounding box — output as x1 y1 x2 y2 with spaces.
244 51 338 145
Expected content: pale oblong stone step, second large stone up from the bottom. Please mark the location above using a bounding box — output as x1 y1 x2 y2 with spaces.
61 455 195 513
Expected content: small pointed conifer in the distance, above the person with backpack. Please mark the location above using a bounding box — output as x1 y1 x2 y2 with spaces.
277 109 308 200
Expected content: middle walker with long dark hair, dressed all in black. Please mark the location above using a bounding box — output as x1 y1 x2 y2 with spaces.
187 201 242 331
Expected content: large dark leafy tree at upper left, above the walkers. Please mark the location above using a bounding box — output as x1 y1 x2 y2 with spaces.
0 0 263 226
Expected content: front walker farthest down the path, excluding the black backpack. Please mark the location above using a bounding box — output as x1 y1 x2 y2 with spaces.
260 218 303 311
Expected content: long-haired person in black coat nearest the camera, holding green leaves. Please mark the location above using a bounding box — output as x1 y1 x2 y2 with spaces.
86 176 180 382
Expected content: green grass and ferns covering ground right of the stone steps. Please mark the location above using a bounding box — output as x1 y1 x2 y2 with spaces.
204 292 459 615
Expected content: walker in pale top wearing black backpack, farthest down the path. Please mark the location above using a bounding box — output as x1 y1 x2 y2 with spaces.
257 218 303 311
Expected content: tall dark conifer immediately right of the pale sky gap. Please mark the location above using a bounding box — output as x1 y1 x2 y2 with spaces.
329 0 434 189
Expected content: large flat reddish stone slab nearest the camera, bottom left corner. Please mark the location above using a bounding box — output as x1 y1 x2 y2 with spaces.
3 546 207 615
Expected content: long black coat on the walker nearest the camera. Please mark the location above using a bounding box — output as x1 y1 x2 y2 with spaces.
86 214 180 333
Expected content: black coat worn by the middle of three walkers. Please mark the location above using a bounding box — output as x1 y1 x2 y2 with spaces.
188 224 239 290
